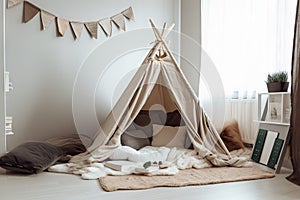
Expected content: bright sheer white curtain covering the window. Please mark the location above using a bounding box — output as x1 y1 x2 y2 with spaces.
200 0 297 143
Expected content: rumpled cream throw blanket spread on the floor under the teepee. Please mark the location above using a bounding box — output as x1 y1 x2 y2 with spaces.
48 146 251 179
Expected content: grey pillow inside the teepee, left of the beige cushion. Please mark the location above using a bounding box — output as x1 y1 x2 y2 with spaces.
121 130 150 150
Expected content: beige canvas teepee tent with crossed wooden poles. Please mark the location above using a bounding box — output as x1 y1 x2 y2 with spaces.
70 20 244 166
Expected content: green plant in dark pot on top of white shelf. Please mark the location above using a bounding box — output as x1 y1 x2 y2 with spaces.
266 71 289 92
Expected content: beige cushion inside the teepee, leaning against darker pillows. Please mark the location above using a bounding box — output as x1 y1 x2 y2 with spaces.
151 124 186 148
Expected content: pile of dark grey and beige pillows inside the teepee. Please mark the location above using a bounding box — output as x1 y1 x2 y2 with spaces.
121 110 191 150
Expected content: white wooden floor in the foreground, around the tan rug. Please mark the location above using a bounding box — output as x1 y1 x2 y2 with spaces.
0 167 300 200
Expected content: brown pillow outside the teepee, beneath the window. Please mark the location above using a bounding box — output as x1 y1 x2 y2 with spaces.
220 120 245 151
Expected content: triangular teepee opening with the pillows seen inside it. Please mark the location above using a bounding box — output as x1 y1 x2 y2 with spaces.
121 84 193 150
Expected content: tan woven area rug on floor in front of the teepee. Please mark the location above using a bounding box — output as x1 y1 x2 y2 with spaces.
99 167 275 192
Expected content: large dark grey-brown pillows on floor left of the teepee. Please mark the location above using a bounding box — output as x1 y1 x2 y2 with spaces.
0 134 92 174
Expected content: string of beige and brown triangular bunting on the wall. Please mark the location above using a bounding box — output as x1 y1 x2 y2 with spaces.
7 0 134 40
